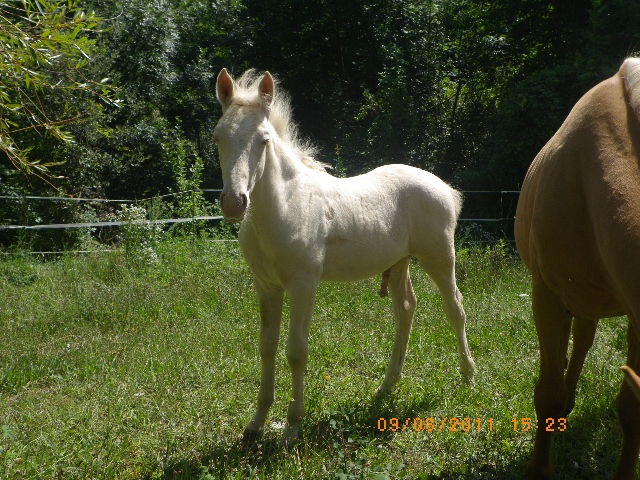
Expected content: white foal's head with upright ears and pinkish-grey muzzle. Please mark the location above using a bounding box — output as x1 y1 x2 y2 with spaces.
213 68 275 222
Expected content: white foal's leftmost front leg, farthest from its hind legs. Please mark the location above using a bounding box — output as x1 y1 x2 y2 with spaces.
242 280 283 441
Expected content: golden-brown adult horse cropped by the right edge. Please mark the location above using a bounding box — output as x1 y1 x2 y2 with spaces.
515 58 640 479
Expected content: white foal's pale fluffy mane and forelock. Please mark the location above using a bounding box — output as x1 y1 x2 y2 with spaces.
231 68 331 171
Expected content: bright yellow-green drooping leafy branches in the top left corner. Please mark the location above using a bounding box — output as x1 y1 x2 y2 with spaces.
0 0 115 175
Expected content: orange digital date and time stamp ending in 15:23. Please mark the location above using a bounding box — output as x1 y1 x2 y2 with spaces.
377 417 567 432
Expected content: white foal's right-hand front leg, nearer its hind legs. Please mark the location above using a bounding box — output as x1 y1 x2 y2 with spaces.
284 278 317 441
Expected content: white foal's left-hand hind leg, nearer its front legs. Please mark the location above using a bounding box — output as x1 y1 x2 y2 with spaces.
376 257 416 397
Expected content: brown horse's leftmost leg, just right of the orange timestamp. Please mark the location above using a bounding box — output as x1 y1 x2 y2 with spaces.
529 277 571 479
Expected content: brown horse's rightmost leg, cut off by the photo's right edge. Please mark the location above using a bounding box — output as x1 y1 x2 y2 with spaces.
614 322 640 480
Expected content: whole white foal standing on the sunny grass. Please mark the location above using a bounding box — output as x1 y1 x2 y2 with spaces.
214 70 474 438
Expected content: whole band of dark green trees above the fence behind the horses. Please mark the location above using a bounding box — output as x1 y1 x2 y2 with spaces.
0 0 640 246
